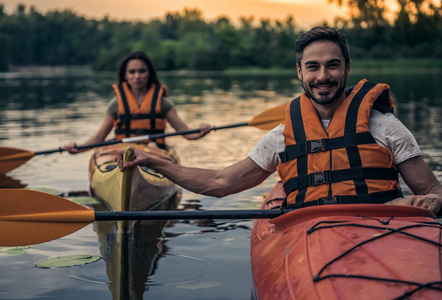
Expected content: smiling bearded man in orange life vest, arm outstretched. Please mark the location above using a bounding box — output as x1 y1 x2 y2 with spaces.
117 27 442 213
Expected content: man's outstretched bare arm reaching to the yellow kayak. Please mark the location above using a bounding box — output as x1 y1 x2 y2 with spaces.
117 149 272 198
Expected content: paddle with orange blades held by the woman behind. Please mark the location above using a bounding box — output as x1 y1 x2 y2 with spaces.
0 103 286 174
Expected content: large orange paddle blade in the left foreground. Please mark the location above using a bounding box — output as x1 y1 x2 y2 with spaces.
0 189 95 247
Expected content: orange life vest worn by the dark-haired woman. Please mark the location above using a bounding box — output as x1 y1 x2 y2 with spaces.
113 82 166 147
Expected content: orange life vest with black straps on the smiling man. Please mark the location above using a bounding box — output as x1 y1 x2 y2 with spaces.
277 79 402 208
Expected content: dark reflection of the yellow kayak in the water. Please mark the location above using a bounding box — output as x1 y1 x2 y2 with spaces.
94 194 180 300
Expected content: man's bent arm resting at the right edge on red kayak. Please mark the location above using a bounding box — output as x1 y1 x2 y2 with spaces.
387 156 442 214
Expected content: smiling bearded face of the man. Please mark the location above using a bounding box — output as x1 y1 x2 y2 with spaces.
297 41 350 105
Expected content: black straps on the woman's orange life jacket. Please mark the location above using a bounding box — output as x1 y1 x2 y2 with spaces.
115 84 164 137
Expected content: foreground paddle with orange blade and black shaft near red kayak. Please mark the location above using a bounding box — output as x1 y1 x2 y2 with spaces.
0 189 291 247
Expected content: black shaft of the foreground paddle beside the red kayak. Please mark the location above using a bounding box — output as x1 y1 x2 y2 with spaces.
95 209 284 221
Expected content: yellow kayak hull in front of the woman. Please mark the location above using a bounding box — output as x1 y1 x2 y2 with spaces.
89 143 181 211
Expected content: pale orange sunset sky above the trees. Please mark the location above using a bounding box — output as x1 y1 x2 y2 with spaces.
0 0 347 29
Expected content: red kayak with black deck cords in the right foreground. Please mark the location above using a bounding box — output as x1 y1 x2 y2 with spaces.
251 183 442 300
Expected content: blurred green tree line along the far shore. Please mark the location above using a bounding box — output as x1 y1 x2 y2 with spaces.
0 0 442 71
